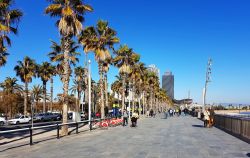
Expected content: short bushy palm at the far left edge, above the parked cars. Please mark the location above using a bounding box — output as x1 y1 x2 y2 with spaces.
0 77 22 116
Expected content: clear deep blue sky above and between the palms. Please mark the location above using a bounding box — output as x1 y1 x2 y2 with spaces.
0 0 250 103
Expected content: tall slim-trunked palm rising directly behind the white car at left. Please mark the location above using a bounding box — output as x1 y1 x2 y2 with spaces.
14 56 37 115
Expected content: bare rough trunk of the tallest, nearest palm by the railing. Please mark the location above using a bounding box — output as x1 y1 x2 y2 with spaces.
61 36 70 136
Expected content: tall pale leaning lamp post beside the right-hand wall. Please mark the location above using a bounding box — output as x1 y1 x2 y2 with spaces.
202 58 212 113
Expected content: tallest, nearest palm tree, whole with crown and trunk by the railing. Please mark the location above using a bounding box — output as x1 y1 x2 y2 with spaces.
45 0 93 135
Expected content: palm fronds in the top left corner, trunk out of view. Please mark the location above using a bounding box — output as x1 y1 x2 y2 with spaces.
0 0 23 66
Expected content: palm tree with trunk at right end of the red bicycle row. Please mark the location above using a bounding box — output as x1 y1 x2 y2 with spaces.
112 45 140 112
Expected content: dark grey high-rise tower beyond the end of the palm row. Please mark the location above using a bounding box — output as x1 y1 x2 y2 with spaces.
162 71 174 99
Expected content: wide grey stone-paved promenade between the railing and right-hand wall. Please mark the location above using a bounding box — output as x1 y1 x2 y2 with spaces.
0 116 250 158
